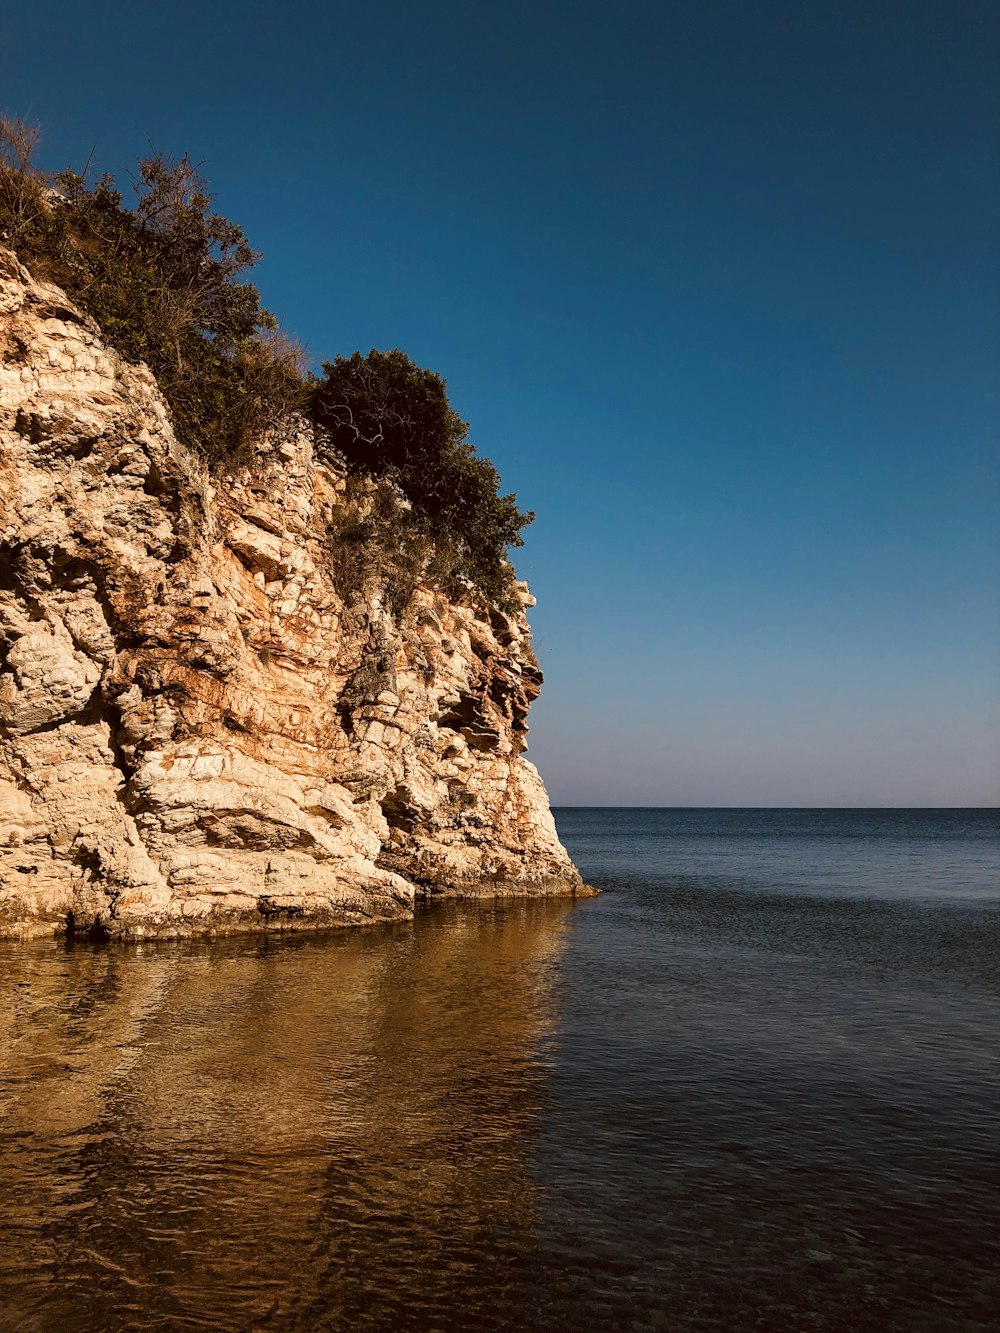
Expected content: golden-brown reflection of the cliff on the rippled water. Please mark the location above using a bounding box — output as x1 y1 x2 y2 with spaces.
0 900 573 1330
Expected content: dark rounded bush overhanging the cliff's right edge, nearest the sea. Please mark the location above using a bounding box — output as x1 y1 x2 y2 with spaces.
312 349 533 604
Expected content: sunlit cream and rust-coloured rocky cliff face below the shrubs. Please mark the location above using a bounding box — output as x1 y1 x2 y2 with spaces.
0 251 585 937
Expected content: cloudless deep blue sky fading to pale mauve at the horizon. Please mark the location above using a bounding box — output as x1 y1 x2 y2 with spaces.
0 0 1000 805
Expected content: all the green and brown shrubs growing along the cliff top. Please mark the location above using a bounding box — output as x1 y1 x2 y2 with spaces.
0 120 532 607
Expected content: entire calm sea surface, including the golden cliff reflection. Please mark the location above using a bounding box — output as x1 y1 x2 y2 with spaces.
0 809 1000 1333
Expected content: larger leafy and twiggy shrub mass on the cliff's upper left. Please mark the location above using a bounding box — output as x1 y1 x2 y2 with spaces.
0 121 305 468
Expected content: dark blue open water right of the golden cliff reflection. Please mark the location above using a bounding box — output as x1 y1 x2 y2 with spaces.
547 809 1000 1330
